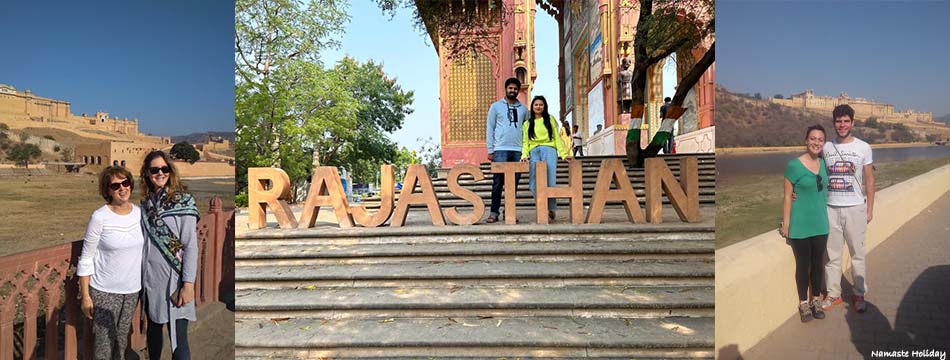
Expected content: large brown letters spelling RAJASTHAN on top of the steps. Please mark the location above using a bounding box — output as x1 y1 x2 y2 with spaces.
248 157 700 229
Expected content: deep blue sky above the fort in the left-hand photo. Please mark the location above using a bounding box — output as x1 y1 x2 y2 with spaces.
0 0 234 135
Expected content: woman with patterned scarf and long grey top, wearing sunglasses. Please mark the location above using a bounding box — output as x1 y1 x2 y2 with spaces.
141 150 198 360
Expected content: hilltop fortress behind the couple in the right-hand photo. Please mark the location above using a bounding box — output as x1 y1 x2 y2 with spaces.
769 89 934 124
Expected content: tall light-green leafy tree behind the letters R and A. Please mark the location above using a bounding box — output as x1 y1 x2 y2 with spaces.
234 0 356 191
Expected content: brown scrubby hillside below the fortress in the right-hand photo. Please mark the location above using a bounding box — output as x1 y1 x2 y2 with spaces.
716 86 923 147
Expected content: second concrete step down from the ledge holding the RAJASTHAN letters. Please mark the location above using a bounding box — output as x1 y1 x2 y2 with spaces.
234 255 715 282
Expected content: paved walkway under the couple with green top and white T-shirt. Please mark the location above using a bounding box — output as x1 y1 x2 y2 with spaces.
742 193 950 360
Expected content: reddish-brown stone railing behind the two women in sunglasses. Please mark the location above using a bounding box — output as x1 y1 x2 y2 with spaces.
0 197 234 360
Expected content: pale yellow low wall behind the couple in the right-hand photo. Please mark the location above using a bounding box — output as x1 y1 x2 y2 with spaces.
716 165 950 360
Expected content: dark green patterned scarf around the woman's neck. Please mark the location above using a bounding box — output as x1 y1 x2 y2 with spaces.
142 189 199 275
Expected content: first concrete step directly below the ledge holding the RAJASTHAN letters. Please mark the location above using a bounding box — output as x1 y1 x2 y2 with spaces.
235 233 715 261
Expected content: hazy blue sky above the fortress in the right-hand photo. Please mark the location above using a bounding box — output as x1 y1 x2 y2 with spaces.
716 0 950 116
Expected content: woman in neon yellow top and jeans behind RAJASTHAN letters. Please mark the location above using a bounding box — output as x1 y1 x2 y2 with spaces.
521 96 568 220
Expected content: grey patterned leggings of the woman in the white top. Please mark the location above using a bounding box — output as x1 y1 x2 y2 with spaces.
89 287 139 360
